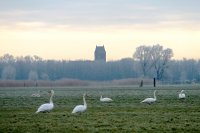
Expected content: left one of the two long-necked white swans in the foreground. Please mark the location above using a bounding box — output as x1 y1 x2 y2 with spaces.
35 90 54 113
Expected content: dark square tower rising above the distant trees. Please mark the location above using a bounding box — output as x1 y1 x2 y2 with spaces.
94 45 106 61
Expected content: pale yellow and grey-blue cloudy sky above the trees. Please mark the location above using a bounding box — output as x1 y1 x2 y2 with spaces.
0 0 200 60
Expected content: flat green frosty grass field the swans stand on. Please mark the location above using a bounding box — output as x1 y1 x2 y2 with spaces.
0 85 200 133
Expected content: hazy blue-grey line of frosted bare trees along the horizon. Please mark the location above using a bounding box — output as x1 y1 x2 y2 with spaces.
0 44 200 83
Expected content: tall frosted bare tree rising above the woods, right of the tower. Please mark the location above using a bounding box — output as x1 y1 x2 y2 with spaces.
133 44 173 80
